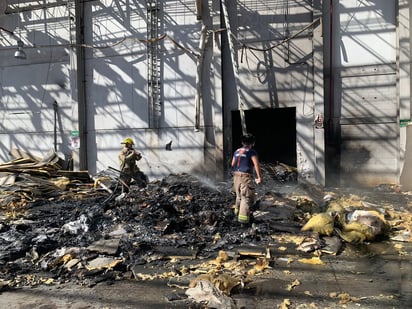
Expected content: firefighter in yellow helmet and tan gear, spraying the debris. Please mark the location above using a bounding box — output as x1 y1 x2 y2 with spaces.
119 137 147 193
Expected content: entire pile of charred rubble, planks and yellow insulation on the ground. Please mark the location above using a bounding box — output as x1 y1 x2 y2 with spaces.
0 151 410 301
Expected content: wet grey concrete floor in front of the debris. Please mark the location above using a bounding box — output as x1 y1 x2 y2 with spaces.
0 241 412 309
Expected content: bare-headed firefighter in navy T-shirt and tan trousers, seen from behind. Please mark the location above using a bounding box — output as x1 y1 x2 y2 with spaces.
231 133 262 225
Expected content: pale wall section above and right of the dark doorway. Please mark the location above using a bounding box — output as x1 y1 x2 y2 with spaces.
224 0 323 182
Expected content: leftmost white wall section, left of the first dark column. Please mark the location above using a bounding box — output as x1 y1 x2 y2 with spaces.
0 1 73 161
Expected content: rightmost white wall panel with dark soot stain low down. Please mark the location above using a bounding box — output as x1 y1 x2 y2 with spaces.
333 0 399 185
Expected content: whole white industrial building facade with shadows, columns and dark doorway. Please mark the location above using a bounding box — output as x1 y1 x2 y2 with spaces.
0 0 411 186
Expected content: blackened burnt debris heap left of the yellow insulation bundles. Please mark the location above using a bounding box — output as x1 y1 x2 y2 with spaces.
0 160 292 286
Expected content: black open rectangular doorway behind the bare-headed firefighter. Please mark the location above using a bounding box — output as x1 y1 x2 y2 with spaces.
232 107 297 167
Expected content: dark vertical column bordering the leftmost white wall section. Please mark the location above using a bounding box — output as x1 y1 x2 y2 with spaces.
75 0 88 170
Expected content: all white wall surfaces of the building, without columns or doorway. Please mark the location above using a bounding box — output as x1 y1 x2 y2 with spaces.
0 0 410 186
